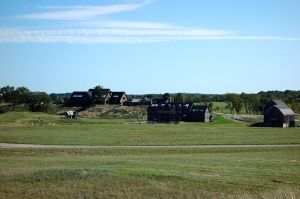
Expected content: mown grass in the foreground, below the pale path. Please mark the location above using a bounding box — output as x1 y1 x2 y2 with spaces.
0 147 300 198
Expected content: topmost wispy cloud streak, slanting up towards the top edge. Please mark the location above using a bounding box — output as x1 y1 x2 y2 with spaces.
18 1 151 20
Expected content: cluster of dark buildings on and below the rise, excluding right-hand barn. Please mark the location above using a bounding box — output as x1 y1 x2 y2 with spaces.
66 89 213 122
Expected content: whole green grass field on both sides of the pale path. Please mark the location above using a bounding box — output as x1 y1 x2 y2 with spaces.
0 112 300 199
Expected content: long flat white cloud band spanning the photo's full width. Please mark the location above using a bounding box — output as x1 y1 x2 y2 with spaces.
0 28 300 44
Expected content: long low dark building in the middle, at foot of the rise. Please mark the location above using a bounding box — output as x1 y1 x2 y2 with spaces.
147 103 213 122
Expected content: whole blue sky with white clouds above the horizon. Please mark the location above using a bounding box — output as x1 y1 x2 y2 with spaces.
0 0 300 94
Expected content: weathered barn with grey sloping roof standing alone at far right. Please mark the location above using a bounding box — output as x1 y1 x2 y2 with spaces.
264 100 295 127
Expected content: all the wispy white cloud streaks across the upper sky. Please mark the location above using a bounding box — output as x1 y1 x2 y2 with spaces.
0 0 300 44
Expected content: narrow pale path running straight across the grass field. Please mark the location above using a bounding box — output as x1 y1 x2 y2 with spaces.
0 143 300 149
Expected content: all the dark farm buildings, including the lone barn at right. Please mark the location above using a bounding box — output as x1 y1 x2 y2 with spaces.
66 89 296 127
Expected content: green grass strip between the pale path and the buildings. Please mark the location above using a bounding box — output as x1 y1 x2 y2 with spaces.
0 112 300 145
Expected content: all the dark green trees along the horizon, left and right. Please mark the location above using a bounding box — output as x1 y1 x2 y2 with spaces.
0 85 300 114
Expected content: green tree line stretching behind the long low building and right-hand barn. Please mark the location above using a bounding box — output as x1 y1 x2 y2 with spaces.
146 90 300 114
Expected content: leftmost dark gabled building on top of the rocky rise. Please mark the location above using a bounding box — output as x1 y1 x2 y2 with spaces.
66 91 93 107
